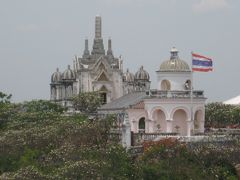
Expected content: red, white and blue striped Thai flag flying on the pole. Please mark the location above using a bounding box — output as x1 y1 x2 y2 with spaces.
192 53 213 72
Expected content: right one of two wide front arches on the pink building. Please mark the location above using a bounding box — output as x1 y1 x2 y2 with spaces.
172 109 187 136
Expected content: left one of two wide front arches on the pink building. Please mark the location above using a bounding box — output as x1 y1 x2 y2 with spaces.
153 109 167 132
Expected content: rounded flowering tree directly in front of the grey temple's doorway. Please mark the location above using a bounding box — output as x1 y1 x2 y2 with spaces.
72 91 101 114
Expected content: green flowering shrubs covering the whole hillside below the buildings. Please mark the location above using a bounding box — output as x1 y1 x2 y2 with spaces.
0 93 240 180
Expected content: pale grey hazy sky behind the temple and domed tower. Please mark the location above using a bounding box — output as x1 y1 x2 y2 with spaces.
0 0 240 102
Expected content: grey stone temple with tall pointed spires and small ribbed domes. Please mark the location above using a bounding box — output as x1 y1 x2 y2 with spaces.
50 16 150 107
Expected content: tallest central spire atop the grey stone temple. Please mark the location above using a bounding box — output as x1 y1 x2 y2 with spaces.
92 16 105 55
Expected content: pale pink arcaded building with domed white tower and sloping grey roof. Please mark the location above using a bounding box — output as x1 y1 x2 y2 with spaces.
99 48 206 136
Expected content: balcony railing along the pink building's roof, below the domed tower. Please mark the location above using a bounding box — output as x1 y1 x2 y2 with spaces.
146 89 204 98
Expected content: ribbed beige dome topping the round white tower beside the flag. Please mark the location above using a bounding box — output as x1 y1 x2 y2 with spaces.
160 47 191 72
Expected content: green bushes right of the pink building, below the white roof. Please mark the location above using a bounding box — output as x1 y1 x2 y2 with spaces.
205 103 240 128
